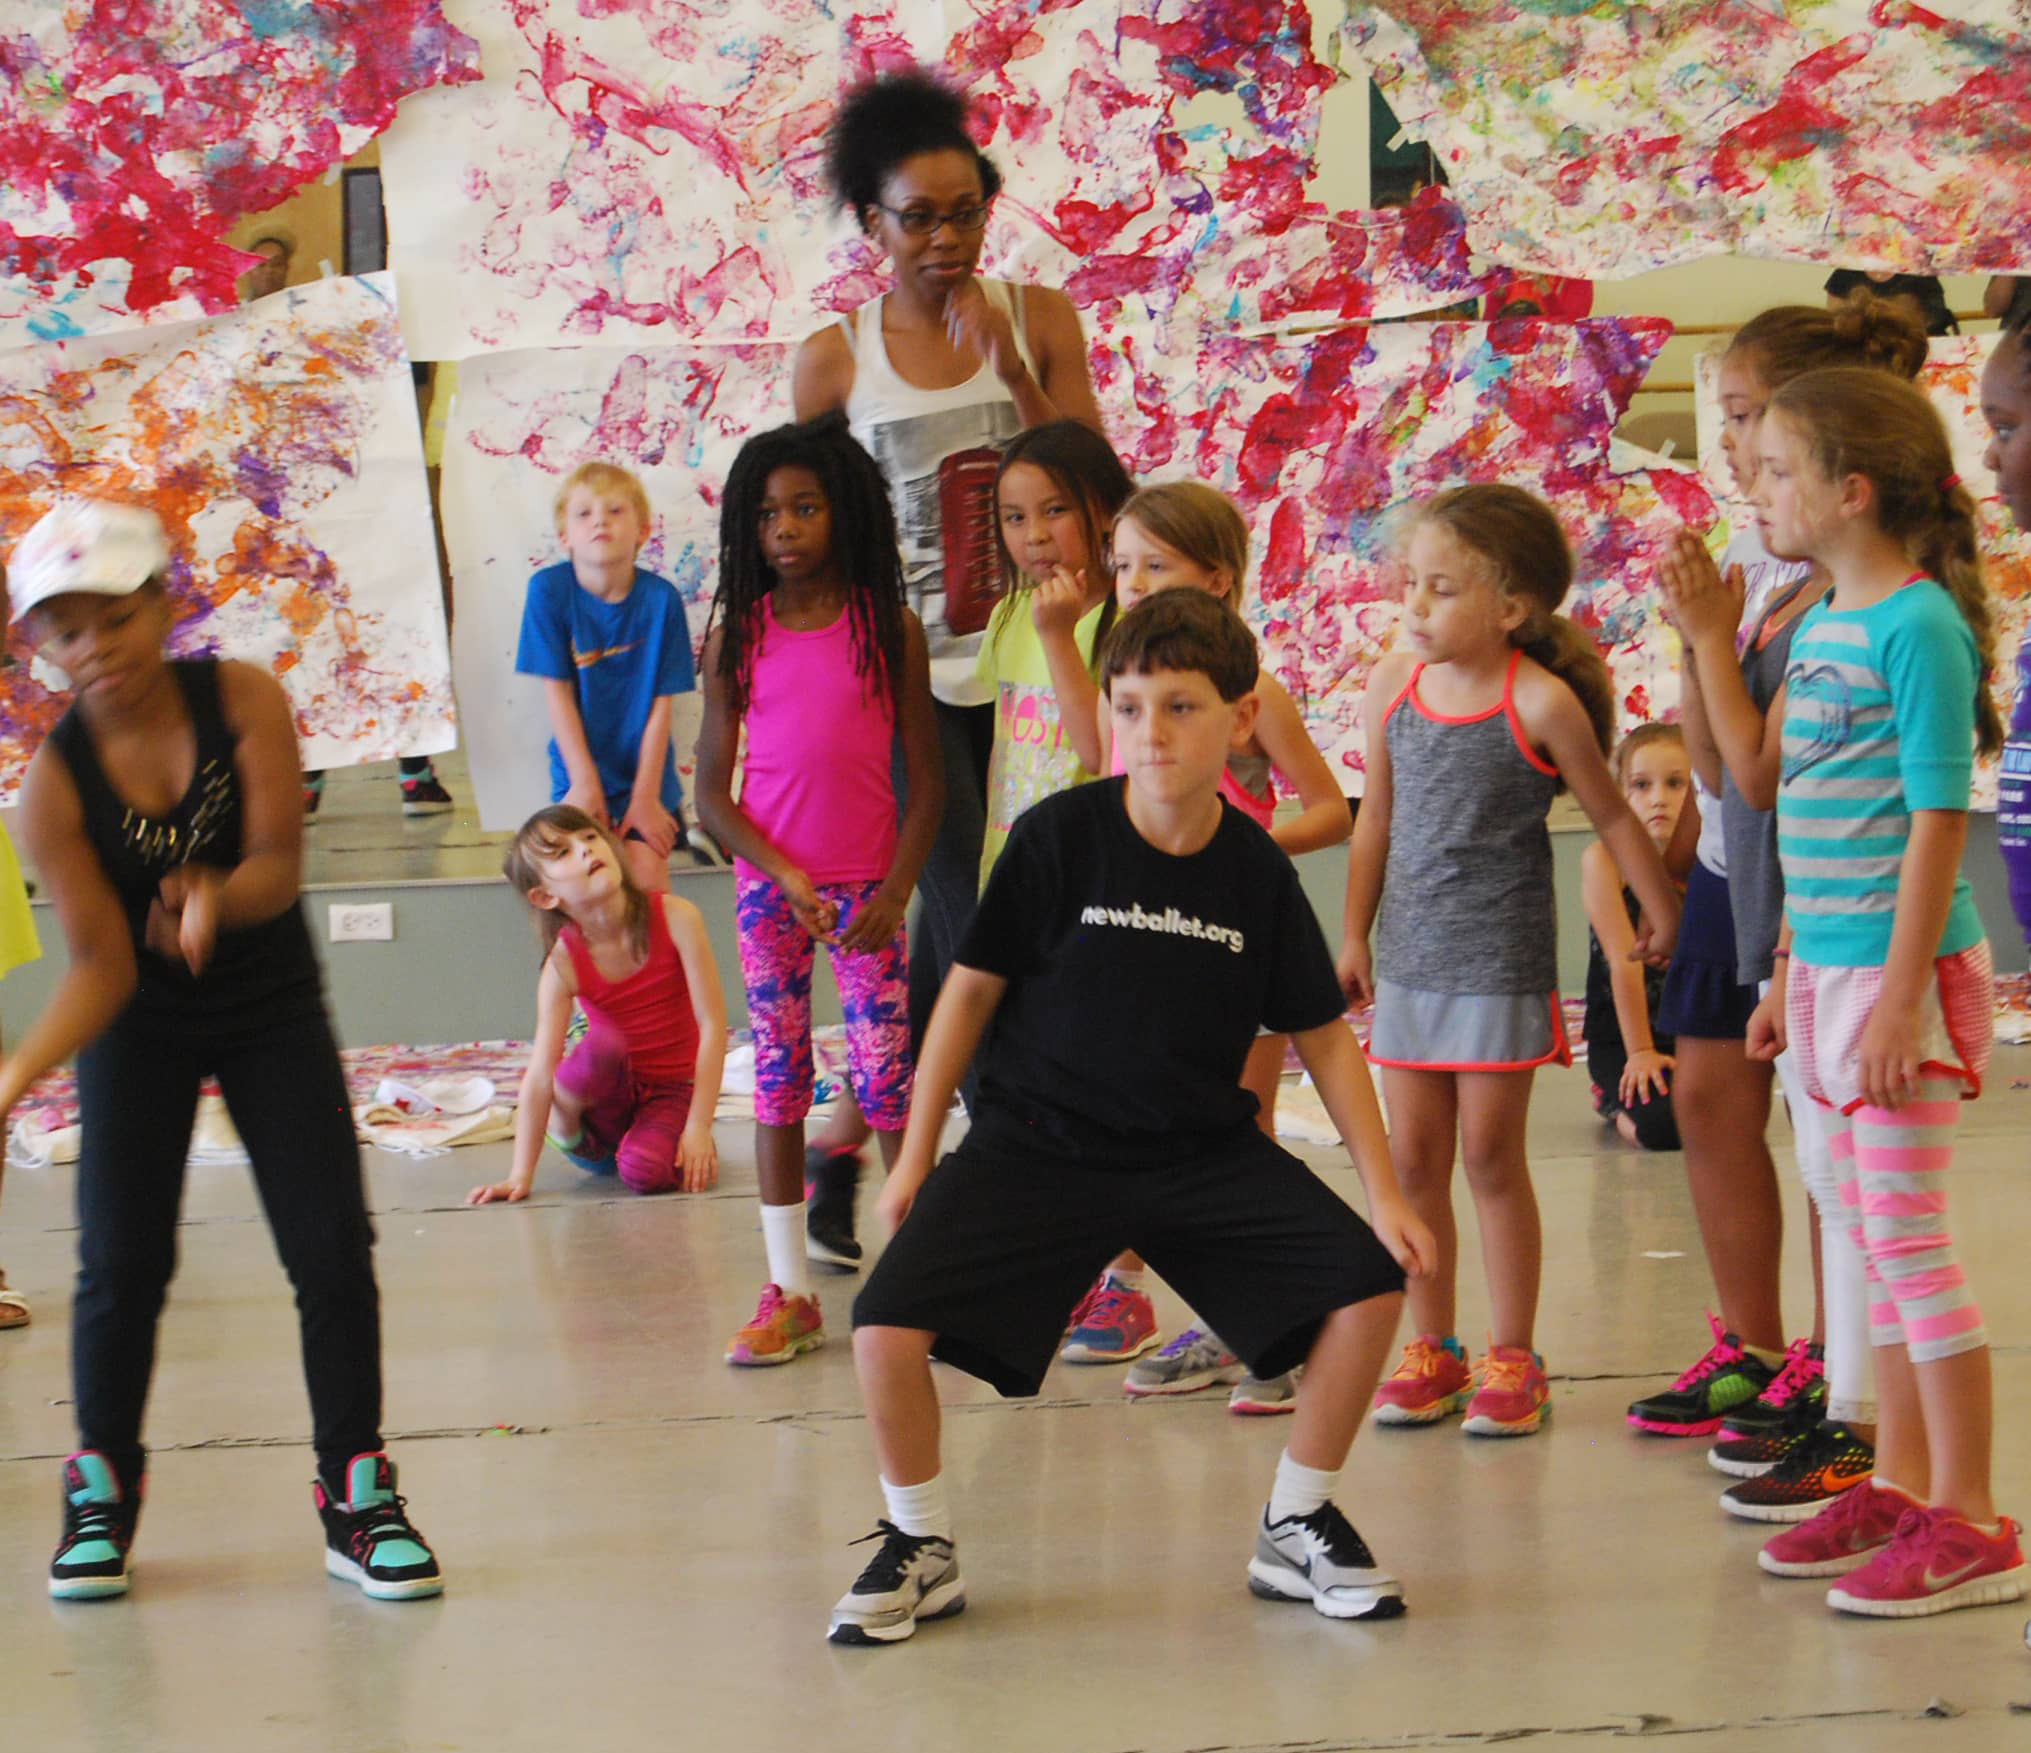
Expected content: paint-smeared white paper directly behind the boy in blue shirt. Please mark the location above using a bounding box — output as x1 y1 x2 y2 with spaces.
443 345 790 831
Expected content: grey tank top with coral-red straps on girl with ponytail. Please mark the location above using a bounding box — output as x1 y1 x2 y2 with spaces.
1375 652 1558 993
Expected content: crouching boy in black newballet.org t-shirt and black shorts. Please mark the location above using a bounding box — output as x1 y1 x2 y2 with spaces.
831 591 1432 1643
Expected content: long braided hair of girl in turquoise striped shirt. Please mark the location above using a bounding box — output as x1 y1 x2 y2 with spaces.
1769 366 2003 756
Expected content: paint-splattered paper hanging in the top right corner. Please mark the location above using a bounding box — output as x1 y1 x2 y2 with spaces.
1349 0 2031 278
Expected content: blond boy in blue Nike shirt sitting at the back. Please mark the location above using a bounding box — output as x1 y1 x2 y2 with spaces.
514 463 697 894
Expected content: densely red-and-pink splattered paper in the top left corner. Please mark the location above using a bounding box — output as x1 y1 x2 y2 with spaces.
0 0 479 345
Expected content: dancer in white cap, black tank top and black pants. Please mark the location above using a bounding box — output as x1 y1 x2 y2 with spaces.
0 500 443 1599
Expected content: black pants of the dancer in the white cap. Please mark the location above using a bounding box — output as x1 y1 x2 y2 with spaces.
71 997 382 1491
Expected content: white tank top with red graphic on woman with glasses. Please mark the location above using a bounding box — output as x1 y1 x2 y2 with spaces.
839 280 1036 707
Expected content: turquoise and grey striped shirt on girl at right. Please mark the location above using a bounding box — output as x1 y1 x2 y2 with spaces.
1777 579 1982 967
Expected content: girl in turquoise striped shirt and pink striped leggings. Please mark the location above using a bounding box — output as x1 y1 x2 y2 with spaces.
1684 368 2025 1619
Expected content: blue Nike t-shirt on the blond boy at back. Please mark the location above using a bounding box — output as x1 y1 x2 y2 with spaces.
514 561 697 817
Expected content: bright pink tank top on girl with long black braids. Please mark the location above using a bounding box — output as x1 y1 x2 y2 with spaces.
735 599 896 884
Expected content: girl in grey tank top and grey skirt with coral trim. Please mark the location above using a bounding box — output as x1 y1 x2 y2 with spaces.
1340 483 1678 1436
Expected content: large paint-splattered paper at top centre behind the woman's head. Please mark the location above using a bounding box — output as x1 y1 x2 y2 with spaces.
382 0 1470 358
